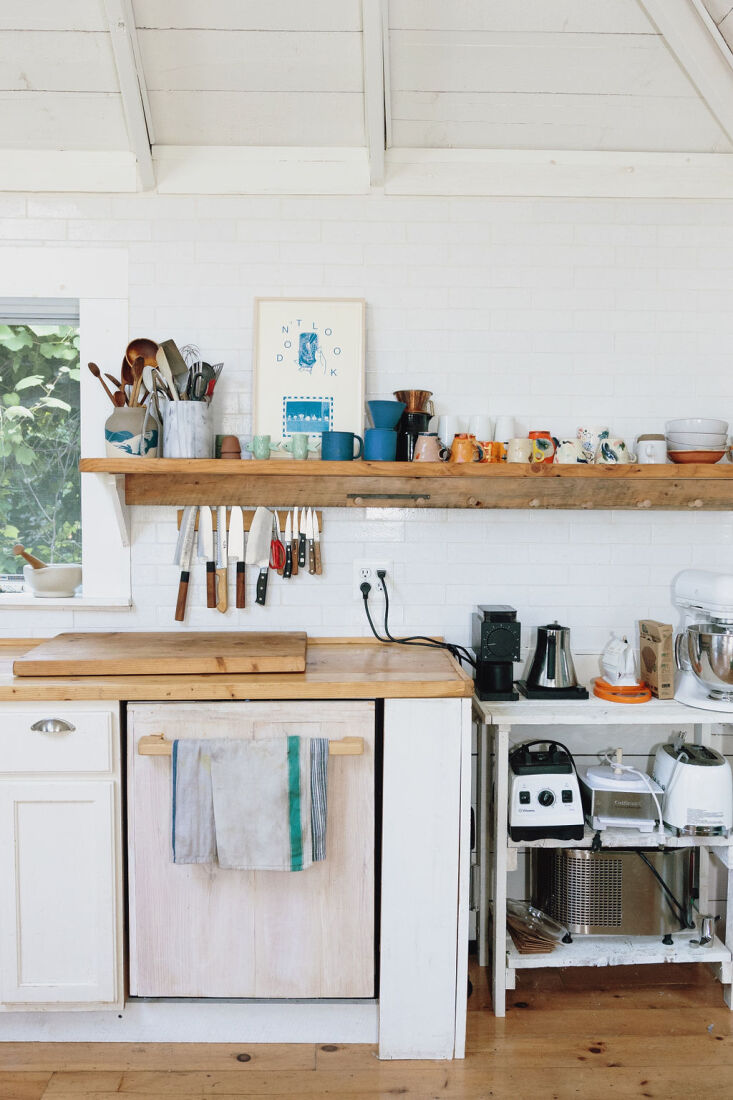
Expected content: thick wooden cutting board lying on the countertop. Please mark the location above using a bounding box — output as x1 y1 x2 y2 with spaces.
13 630 307 677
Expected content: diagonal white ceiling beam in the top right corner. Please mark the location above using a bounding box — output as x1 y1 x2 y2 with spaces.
638 0 733 142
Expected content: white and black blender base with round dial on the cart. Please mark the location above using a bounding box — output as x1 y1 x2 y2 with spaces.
508 741 584 840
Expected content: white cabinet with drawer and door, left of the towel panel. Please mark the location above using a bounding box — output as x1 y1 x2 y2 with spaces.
0 703 122 1011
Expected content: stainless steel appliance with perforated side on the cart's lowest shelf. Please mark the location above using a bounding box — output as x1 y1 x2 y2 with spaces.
532 848 691 936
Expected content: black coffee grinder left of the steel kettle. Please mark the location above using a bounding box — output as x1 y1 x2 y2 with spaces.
471 604 522 702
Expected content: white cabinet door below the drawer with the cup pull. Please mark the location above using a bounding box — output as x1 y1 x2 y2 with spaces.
0 780 117 1004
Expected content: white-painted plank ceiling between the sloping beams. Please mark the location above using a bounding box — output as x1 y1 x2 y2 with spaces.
0 0 733 172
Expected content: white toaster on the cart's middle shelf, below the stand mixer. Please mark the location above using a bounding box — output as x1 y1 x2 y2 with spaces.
654 740 733 836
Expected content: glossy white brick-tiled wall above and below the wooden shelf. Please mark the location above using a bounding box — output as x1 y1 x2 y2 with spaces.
0 196 733 651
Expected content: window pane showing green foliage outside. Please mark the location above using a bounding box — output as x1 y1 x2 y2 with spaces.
0 303 81 573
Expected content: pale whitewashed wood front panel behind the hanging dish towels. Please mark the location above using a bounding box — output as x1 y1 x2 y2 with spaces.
128 702 374 998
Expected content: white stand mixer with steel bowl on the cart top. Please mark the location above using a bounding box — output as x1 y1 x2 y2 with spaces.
672 569 733 713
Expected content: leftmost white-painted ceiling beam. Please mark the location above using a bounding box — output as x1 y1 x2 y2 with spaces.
105 0 155 191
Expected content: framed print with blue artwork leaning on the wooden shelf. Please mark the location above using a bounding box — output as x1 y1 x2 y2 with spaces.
252 298 365 442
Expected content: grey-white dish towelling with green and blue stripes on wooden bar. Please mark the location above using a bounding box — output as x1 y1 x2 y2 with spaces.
172 737 328 871
